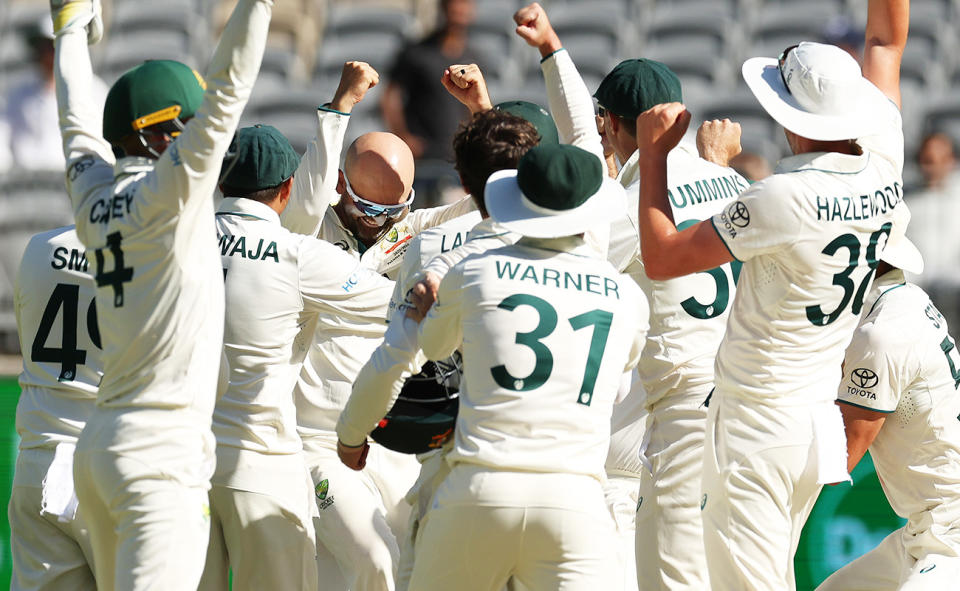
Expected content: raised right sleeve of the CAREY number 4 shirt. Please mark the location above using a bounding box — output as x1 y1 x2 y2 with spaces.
140 0 273 215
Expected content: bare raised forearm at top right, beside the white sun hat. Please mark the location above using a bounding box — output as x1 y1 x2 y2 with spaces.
862 0 910 107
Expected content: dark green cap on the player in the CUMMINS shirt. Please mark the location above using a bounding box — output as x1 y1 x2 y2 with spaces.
593 58 683 119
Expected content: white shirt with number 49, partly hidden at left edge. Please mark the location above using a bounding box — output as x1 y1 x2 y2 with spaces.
13 226 103 449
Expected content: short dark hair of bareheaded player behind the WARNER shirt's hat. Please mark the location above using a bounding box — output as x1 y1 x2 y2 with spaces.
453 109 540 215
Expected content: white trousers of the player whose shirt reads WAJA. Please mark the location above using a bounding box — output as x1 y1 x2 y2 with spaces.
199 484 317 591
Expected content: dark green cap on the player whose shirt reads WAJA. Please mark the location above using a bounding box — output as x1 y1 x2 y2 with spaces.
221 125 300 197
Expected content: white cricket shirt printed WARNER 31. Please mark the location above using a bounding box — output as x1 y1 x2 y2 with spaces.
420 237 647 479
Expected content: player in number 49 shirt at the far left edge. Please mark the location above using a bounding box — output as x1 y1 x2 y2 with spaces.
7 226 103 591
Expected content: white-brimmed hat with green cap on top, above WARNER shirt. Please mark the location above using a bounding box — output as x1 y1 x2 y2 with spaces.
483 144 626 238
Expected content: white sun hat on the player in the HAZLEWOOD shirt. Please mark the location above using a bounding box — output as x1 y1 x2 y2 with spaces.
742 42 888 141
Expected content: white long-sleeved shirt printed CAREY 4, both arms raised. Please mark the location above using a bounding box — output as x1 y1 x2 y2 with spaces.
56 0 272 426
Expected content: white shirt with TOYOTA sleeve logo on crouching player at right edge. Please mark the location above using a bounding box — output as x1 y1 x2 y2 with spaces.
838 270 960 555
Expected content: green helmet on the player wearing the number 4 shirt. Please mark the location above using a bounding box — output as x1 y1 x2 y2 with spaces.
103 60 207 144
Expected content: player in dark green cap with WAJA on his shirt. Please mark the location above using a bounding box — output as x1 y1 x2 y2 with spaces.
200 126 393 590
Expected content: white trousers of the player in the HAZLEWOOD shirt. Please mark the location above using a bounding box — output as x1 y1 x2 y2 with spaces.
702 389 824 591
